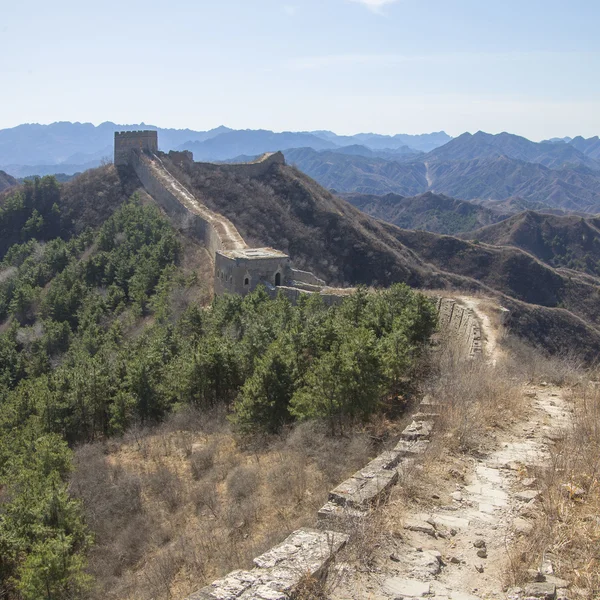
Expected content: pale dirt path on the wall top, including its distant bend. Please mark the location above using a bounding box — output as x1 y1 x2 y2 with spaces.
329 297 572 600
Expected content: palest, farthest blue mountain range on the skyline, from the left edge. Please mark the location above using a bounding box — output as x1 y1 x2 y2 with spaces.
0 121 451 177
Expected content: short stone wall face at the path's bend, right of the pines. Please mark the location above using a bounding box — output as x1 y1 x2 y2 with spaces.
435 297 482 357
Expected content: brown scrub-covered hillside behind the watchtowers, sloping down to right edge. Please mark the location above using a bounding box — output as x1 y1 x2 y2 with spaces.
157 153 600 358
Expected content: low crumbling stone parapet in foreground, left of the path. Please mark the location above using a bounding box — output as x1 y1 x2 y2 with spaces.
186 398 438 600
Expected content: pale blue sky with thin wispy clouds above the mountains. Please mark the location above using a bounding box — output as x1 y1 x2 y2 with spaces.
0 0 600 140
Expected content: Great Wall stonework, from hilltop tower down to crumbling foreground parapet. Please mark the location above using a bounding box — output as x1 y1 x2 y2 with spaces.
115 131 492 600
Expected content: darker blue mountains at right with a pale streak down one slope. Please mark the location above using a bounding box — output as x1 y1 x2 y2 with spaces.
285 132 600 213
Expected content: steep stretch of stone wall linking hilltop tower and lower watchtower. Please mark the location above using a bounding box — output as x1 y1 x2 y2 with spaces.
129 151 247 259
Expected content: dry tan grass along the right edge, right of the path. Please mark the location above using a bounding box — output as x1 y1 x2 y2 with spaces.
510 373 600 600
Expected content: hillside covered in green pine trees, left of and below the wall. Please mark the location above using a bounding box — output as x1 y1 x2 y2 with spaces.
0 168 435 600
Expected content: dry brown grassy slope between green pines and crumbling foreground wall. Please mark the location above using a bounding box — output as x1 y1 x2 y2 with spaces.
71 409 376 600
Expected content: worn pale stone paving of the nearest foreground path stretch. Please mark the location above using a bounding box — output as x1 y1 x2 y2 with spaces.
330 386 572 600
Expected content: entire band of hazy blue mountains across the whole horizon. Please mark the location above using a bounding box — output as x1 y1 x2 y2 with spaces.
0 122 600 213
